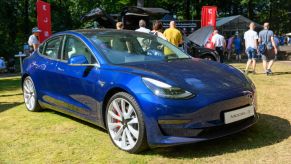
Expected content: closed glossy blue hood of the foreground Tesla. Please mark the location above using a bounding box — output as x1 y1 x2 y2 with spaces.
114 59 248 92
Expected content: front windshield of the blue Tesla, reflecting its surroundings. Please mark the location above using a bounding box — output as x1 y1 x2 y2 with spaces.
85 31 191 64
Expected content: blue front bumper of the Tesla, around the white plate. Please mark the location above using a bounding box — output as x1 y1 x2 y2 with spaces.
139 89 258 147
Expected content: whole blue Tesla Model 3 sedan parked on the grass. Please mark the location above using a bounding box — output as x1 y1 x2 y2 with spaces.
22 29 258 153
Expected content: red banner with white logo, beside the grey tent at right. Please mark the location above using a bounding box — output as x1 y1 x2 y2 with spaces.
201 6 217 28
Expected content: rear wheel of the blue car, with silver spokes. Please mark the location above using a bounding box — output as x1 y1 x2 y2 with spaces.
22 76 42 112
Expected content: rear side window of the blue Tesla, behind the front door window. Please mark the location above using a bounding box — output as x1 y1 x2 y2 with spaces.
43 37 62 59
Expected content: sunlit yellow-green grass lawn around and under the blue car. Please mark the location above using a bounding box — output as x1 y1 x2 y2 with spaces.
0 62 291 163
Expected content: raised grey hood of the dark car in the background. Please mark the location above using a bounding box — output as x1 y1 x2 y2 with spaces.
187 26 213 47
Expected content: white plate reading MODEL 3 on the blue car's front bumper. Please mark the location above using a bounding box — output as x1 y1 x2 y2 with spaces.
224 105 255 124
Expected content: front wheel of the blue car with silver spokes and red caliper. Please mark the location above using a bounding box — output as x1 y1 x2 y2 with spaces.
105 92 148 153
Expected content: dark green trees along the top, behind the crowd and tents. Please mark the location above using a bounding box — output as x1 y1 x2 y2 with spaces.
0 0 291 59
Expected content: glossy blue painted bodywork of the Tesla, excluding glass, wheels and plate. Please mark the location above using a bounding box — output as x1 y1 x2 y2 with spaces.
23 31 257 147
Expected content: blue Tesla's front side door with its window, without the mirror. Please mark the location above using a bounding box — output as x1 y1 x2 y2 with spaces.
55 35 101 121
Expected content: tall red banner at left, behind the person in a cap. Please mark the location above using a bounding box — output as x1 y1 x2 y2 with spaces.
36 0 51 42
